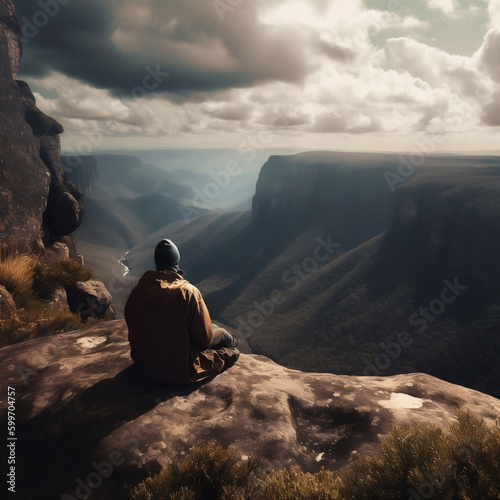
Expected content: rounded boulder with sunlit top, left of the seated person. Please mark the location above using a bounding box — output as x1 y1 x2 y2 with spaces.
66 280 113 321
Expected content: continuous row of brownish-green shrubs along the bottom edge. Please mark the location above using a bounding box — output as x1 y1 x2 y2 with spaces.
131 412 500 500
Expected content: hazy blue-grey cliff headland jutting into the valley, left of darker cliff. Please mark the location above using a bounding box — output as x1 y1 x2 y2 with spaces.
252 152 397 249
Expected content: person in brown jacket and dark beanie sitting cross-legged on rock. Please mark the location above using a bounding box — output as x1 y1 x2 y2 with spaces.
125 239 239 385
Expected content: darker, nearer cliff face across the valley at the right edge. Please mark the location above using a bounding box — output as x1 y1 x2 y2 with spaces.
385 167 500 292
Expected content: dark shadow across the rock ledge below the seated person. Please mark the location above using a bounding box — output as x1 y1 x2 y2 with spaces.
3 366 205 500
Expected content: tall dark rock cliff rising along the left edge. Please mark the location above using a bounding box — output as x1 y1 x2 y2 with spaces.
0 0 83 252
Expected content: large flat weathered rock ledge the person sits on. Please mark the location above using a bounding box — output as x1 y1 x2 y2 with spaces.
0 320 500 500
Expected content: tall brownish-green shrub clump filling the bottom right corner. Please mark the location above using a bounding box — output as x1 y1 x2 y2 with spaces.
340 412 500 500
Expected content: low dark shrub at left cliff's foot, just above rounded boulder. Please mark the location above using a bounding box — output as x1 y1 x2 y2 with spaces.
33 259 92 297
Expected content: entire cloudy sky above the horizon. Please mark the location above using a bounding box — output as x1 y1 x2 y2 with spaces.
10 0 500 152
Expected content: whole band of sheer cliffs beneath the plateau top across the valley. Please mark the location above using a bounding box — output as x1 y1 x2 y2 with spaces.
252 152 500 288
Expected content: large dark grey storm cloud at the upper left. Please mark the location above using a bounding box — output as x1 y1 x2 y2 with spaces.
14 0 309 99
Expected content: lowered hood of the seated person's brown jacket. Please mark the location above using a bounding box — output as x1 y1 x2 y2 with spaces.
137 271 189 308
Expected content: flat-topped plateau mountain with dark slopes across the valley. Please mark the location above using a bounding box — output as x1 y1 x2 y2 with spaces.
123 152 500 395
